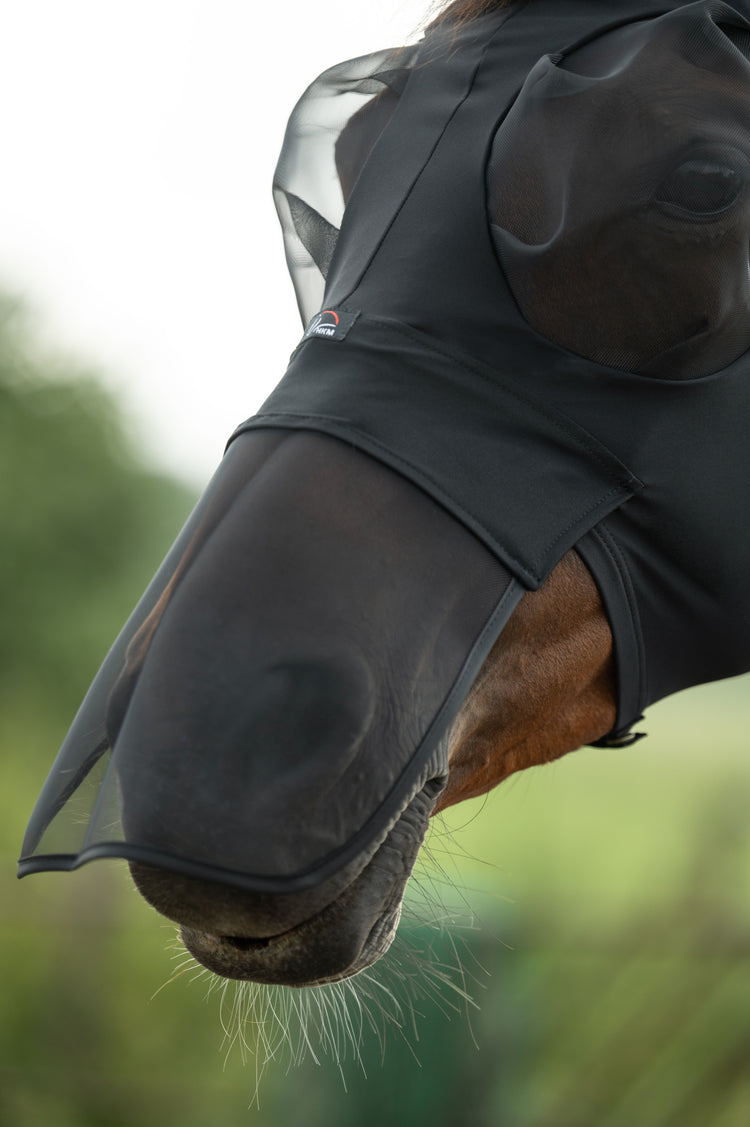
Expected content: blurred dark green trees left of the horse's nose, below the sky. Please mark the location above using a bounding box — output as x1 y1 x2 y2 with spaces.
0 299 196 712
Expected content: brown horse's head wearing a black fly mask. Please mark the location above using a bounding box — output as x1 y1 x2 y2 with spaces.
20 0 750 1005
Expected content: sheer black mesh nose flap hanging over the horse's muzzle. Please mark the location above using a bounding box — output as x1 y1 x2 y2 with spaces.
21 431 519 890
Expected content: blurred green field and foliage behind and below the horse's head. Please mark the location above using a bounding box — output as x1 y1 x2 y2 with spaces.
0 299 750 1127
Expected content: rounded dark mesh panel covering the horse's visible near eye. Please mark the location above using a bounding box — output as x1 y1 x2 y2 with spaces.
487 5 750 379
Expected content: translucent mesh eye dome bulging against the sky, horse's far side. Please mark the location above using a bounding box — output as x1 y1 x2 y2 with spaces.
274 47 416 325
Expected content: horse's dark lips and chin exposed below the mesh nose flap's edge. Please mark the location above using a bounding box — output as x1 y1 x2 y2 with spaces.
131 784 435 986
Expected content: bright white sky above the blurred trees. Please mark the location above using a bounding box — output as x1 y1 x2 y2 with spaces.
0 0 429 485
